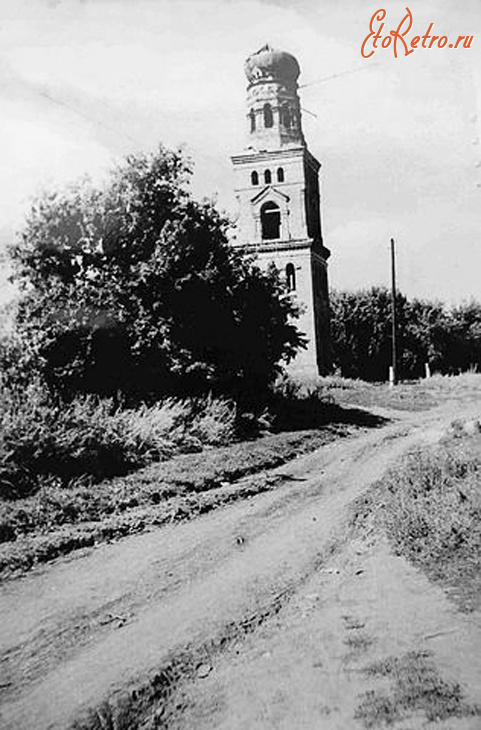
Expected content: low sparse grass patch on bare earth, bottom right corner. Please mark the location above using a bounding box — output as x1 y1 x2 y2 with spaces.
355 652 481 728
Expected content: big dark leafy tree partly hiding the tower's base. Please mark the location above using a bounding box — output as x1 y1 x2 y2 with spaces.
11 148 303 397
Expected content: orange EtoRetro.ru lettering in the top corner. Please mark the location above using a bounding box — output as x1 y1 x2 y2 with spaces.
361 8 473 58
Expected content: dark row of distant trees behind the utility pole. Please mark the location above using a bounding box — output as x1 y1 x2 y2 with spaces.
331 287 481 381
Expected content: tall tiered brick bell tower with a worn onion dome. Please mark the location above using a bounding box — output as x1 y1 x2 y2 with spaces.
232 45 330 375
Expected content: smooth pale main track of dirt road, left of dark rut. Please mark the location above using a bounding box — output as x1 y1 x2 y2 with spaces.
0 406 472 730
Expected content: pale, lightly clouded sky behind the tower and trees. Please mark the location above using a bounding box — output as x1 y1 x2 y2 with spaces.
0 0 481 304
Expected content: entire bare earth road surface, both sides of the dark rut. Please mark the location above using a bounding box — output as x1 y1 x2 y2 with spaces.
0 403 481 730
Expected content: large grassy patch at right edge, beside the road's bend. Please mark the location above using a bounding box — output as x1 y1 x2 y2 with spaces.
384 428 481 608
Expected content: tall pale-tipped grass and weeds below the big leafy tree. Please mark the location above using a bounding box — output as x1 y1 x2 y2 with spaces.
0 383 236 499
